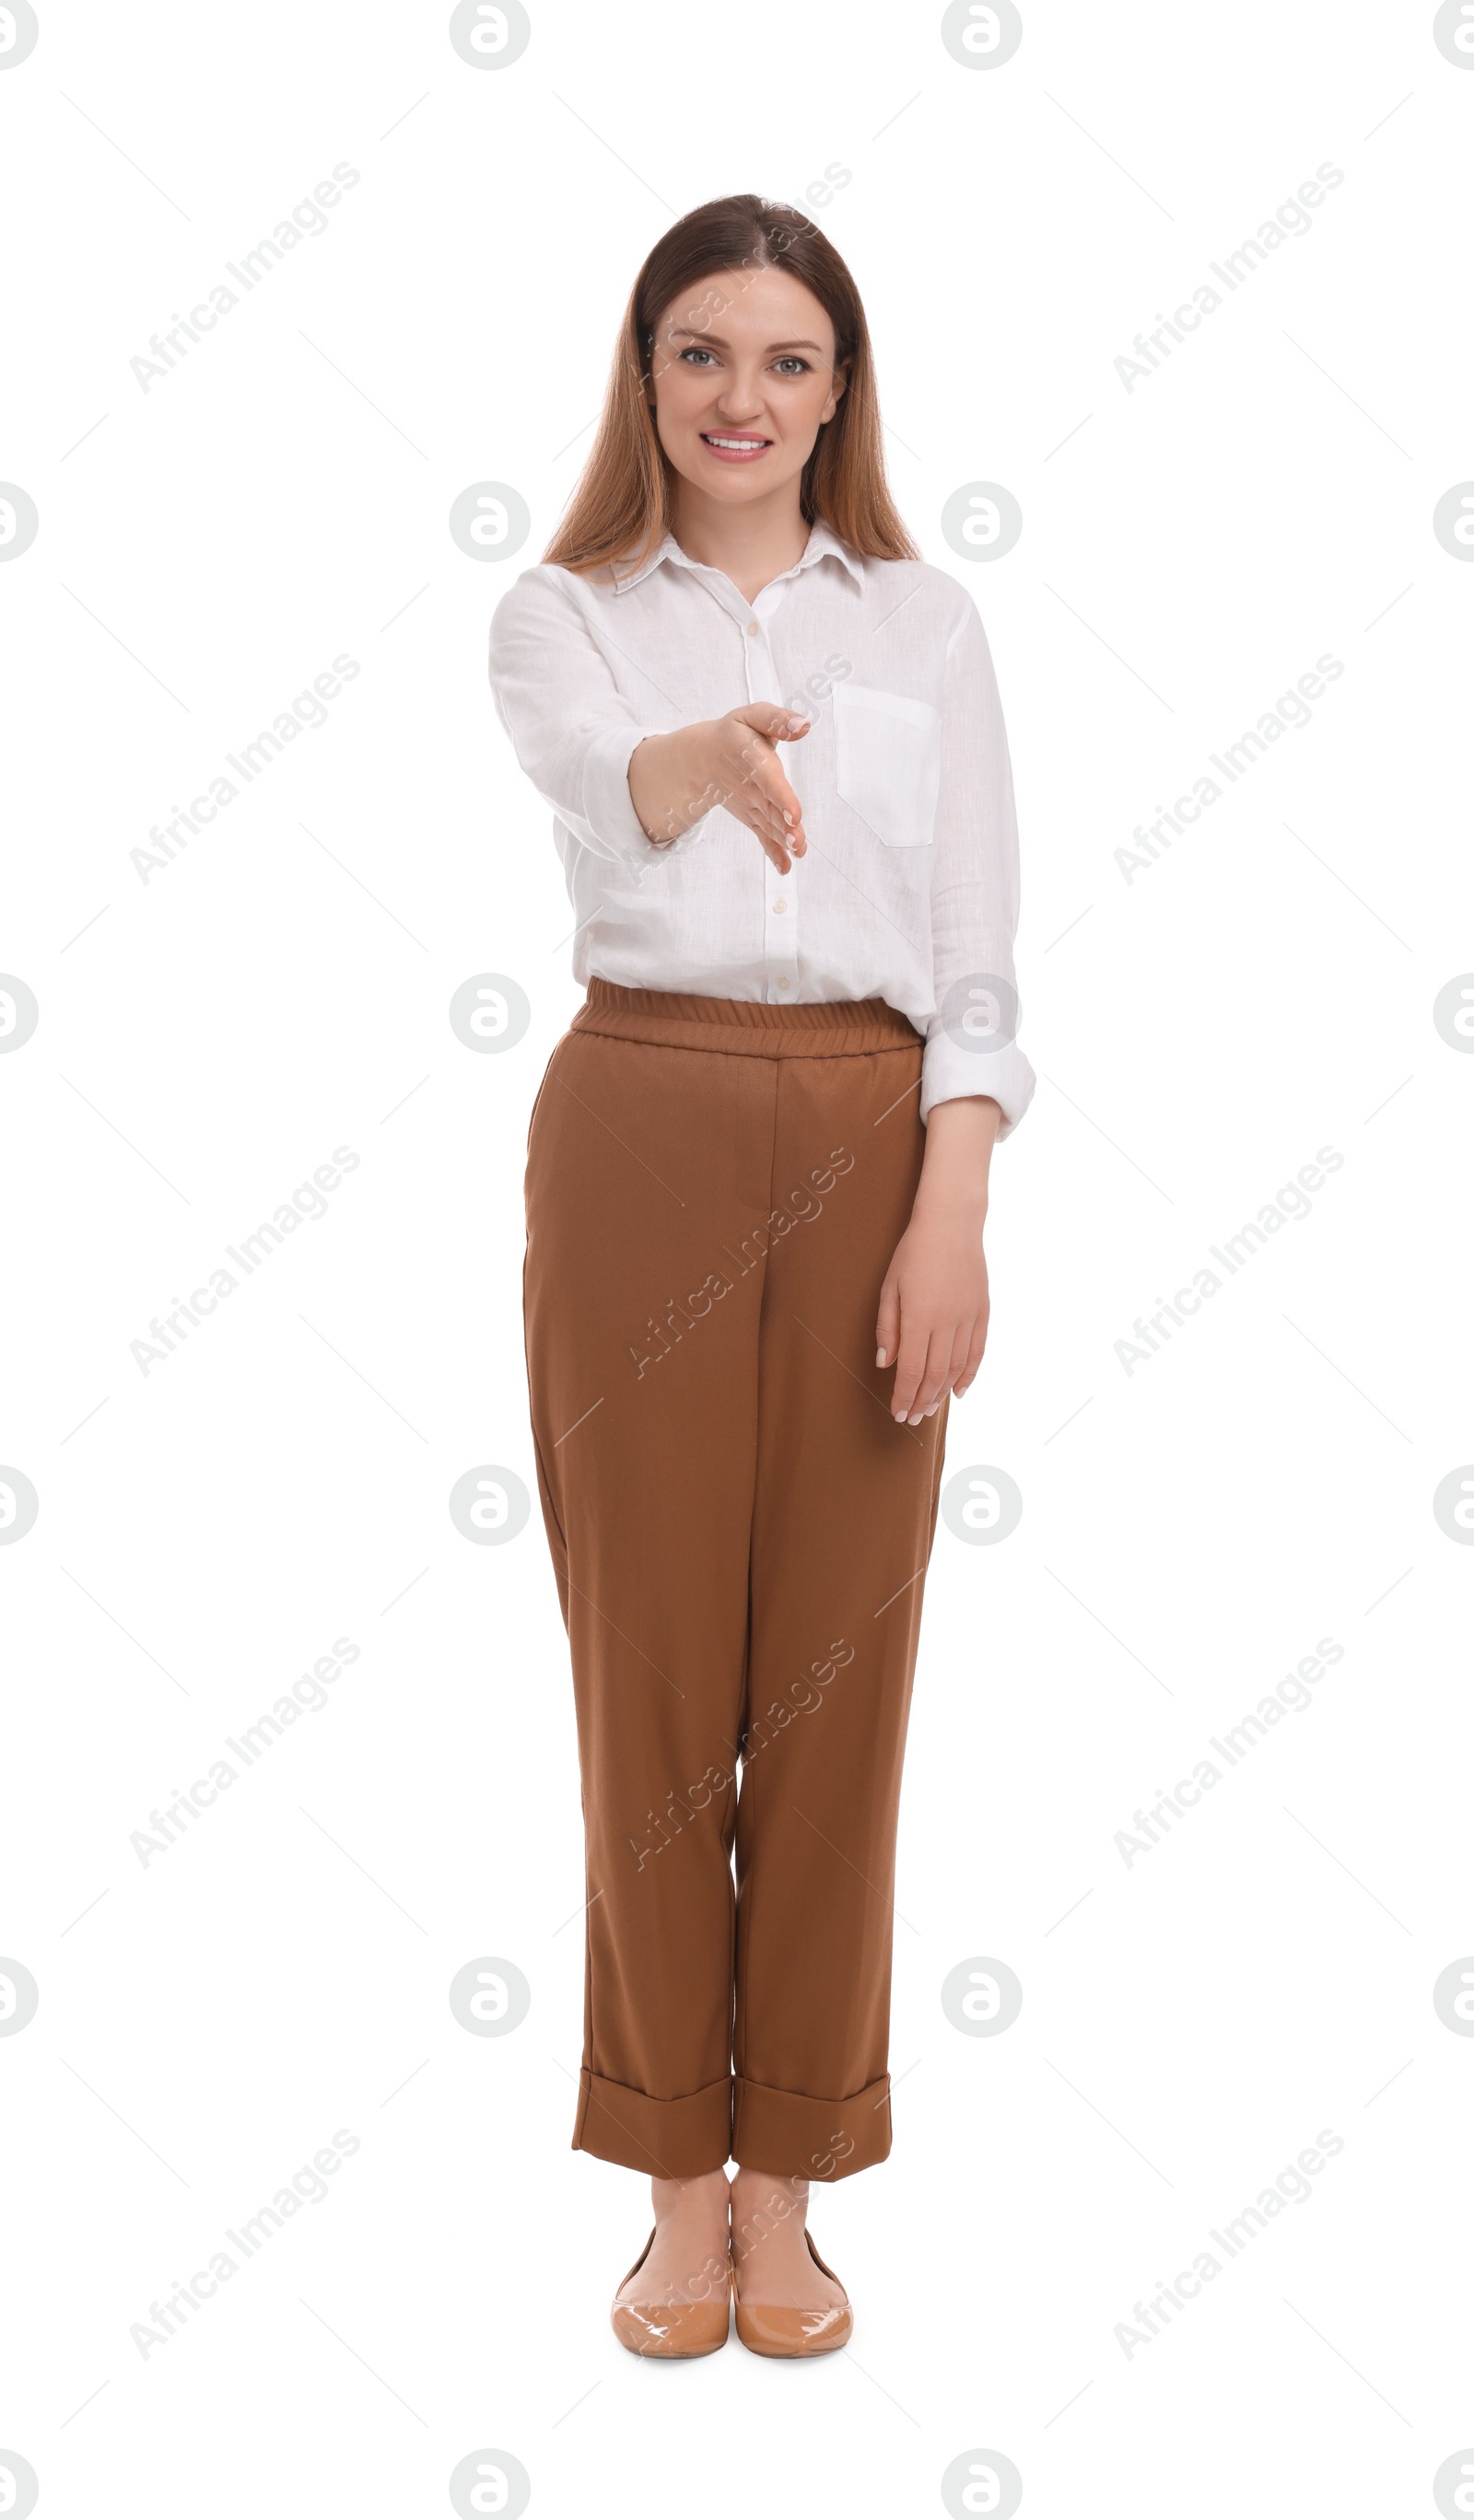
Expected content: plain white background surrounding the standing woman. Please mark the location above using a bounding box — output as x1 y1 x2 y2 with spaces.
0 0 1474 2520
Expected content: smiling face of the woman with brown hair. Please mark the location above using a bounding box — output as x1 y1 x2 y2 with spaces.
650 267 844 507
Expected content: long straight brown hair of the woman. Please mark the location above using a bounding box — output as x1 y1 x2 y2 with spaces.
542 192 919 575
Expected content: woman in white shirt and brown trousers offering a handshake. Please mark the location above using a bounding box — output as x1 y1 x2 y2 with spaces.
491 194 1033 2356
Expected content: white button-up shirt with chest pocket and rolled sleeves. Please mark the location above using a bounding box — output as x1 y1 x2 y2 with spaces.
491 524 1035 1134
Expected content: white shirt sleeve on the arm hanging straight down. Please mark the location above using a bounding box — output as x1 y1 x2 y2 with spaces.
919 597 1035 1139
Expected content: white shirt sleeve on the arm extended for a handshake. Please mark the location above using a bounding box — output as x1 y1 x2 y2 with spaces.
489 567 710 869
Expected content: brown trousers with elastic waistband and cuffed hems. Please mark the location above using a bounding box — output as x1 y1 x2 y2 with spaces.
524 978 947 2180
